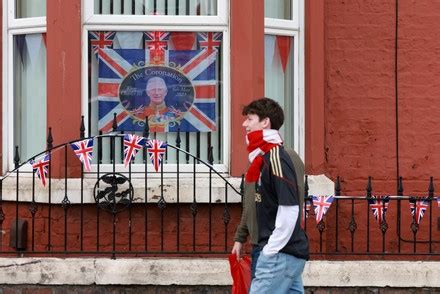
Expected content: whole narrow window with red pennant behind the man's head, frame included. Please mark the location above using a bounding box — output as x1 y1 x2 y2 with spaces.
264 0 304 158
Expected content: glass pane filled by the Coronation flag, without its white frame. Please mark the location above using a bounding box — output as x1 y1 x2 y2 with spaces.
89 31 224 163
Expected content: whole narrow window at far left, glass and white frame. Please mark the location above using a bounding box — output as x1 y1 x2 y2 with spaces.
3 0 46 171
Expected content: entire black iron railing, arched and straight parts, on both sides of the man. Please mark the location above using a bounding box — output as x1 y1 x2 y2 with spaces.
0 116 440 260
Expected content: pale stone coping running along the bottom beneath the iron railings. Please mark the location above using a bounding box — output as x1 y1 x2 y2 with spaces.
0 258 440 288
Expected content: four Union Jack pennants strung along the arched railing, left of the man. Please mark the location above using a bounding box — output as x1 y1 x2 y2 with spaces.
29 134 167 187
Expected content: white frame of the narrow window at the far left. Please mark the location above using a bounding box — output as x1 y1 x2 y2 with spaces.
2 0 46 173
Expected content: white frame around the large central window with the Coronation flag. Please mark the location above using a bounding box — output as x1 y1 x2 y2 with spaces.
81 0 231 174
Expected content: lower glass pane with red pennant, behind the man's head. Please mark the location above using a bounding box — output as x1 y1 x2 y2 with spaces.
264 35 295 148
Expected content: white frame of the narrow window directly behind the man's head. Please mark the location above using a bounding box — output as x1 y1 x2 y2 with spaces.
264 0 306 161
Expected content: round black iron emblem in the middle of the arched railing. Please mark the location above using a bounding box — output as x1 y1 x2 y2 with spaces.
93 173 134 213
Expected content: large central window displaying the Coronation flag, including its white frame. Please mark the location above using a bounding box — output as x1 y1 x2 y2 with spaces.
83 0 229 171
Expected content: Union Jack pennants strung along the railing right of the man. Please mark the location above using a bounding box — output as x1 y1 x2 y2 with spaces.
303 195 440 225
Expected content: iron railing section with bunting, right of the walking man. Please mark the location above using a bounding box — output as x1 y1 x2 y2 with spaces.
302 177 440 258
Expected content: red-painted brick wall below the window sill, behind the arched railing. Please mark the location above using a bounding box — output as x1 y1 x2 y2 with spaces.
0 202 240 256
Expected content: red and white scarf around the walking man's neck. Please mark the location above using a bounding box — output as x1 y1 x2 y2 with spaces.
245 129 283 183
